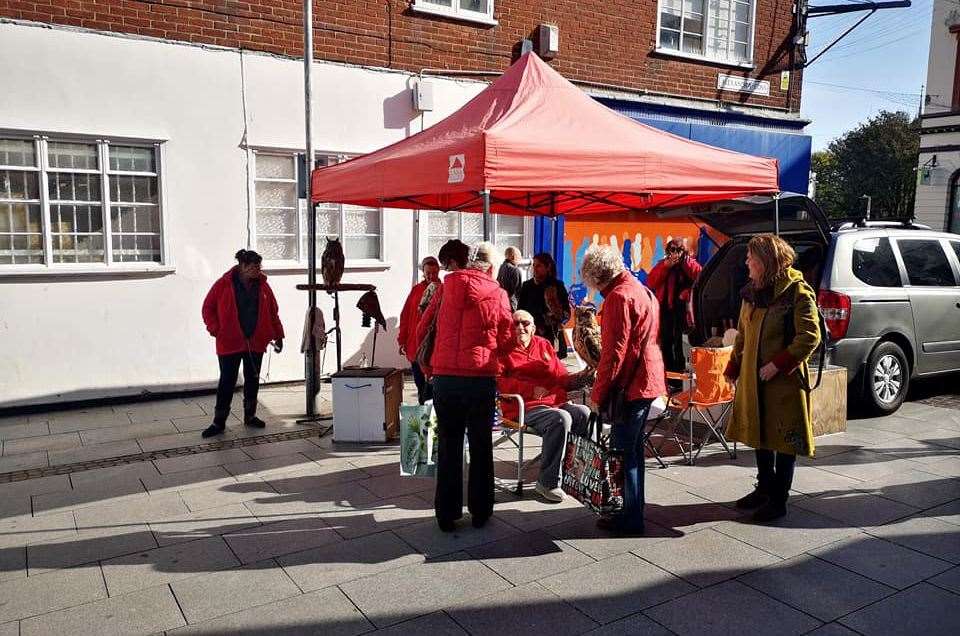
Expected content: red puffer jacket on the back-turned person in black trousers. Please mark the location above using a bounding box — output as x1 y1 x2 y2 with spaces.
417 268 513 377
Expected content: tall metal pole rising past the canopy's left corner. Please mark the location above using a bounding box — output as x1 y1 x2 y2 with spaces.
303 0 318 417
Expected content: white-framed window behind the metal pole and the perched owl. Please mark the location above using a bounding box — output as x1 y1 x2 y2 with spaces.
252 150 384 266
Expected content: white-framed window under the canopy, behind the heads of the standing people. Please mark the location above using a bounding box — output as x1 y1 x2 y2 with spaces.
420 210 532 256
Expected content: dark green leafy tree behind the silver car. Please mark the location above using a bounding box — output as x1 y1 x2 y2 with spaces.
811 111 920 219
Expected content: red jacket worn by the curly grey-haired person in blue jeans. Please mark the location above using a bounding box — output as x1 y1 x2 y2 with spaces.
592 272 667 404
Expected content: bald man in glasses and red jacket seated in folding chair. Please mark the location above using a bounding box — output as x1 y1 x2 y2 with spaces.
497 310 590 503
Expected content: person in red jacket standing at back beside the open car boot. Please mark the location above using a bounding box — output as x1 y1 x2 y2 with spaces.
647 239 702 371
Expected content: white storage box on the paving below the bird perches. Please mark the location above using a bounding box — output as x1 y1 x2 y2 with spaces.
331 367 403 442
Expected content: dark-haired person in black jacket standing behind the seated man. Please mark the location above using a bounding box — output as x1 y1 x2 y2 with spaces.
517 252 570 358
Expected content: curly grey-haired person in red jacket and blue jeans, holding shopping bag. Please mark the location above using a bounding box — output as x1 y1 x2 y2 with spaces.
580 245 667 534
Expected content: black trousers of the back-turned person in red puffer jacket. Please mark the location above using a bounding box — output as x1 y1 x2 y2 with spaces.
433 375 497 521
